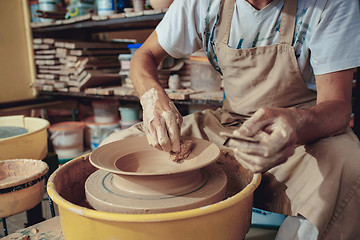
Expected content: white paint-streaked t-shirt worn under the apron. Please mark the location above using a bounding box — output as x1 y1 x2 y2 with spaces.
156 0 360 85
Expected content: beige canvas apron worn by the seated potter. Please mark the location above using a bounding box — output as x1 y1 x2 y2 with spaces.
108 0 360 240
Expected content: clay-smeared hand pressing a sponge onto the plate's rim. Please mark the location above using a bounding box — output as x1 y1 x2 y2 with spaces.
140 88 182 152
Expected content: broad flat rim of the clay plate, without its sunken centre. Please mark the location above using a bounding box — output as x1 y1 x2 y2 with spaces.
89 136 220 176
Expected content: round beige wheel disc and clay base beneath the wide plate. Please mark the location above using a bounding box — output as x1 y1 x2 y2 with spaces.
85 165 227 213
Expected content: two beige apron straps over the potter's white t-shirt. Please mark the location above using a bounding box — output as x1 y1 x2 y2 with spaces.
218 0 298 45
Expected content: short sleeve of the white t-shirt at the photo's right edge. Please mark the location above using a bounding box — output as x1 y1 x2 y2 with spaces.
309 0 360 75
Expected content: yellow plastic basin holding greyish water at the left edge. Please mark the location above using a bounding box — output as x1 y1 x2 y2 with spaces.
0 115 50 160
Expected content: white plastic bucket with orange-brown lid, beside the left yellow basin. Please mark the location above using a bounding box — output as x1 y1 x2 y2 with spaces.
49 121 84 162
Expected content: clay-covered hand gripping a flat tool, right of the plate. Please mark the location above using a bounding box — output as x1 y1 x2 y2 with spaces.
229 108 297 173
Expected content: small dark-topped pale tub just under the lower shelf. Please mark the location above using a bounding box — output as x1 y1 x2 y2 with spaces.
92 100 119 123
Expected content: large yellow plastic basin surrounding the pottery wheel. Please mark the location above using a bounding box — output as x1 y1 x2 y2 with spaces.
47 151 261 240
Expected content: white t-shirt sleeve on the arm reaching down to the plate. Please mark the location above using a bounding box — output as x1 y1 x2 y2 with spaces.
156 0 202 58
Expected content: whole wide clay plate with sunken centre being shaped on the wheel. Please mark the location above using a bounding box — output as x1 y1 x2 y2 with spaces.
90 136 220 176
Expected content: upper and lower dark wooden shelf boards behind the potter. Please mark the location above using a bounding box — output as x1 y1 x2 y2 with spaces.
32 9 223 109
